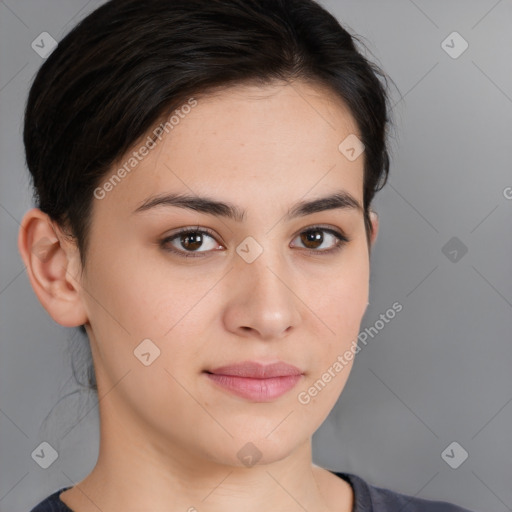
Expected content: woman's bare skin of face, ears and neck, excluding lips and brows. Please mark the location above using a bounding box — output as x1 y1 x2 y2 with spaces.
19 82 378 512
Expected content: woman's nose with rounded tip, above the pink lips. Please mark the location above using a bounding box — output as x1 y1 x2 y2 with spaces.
223 251 305 340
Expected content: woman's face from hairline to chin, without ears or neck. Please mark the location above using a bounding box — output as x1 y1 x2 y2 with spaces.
80 83 376 467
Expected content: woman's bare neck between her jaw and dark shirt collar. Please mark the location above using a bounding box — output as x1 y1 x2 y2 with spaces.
62 400 344 512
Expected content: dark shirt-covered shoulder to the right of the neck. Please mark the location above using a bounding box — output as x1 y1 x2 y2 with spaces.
335 472 478 512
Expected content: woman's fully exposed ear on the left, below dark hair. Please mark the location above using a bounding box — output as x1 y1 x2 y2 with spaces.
18 208 88 327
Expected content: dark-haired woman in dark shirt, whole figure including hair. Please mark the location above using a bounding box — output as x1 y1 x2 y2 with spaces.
19 0 476 512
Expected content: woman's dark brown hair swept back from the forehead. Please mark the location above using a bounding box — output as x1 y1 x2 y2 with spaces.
23 0 396 396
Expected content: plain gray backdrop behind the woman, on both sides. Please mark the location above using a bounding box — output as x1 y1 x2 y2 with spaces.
0 0 512 512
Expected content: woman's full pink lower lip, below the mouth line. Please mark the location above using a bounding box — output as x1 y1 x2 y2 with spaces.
206 373 302 402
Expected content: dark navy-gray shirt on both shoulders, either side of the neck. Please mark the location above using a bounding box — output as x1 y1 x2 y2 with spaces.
30 471 472 512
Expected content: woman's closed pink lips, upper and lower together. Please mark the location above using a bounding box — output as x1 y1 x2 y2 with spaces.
206 361 303 402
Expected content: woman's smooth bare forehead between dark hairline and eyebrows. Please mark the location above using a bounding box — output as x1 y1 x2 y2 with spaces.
93 82 363 218
